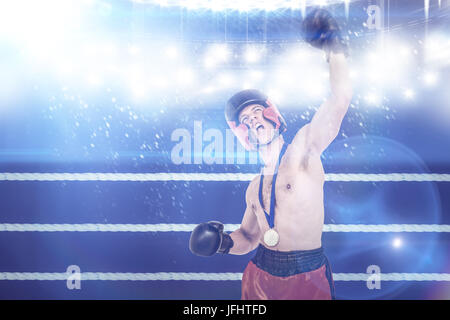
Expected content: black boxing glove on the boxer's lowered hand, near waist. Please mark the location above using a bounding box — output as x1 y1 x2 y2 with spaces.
189 221 234 257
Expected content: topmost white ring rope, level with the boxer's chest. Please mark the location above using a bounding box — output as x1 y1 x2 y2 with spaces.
0 172 450 182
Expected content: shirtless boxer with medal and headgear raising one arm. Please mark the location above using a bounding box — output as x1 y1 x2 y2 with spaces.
189 9 352 300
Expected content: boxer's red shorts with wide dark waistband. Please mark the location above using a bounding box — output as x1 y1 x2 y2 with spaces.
242 245 334 300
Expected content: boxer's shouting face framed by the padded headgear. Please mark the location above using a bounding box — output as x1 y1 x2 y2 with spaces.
239 104 275 144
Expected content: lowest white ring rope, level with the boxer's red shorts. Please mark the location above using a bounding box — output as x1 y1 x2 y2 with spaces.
0 272 450 281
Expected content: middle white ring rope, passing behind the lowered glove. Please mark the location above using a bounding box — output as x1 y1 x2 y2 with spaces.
0 223 450 232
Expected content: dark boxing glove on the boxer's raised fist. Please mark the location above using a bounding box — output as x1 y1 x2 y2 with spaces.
301 8 348 56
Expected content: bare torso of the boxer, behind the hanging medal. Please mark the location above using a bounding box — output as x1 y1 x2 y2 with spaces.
248 141 325 251
